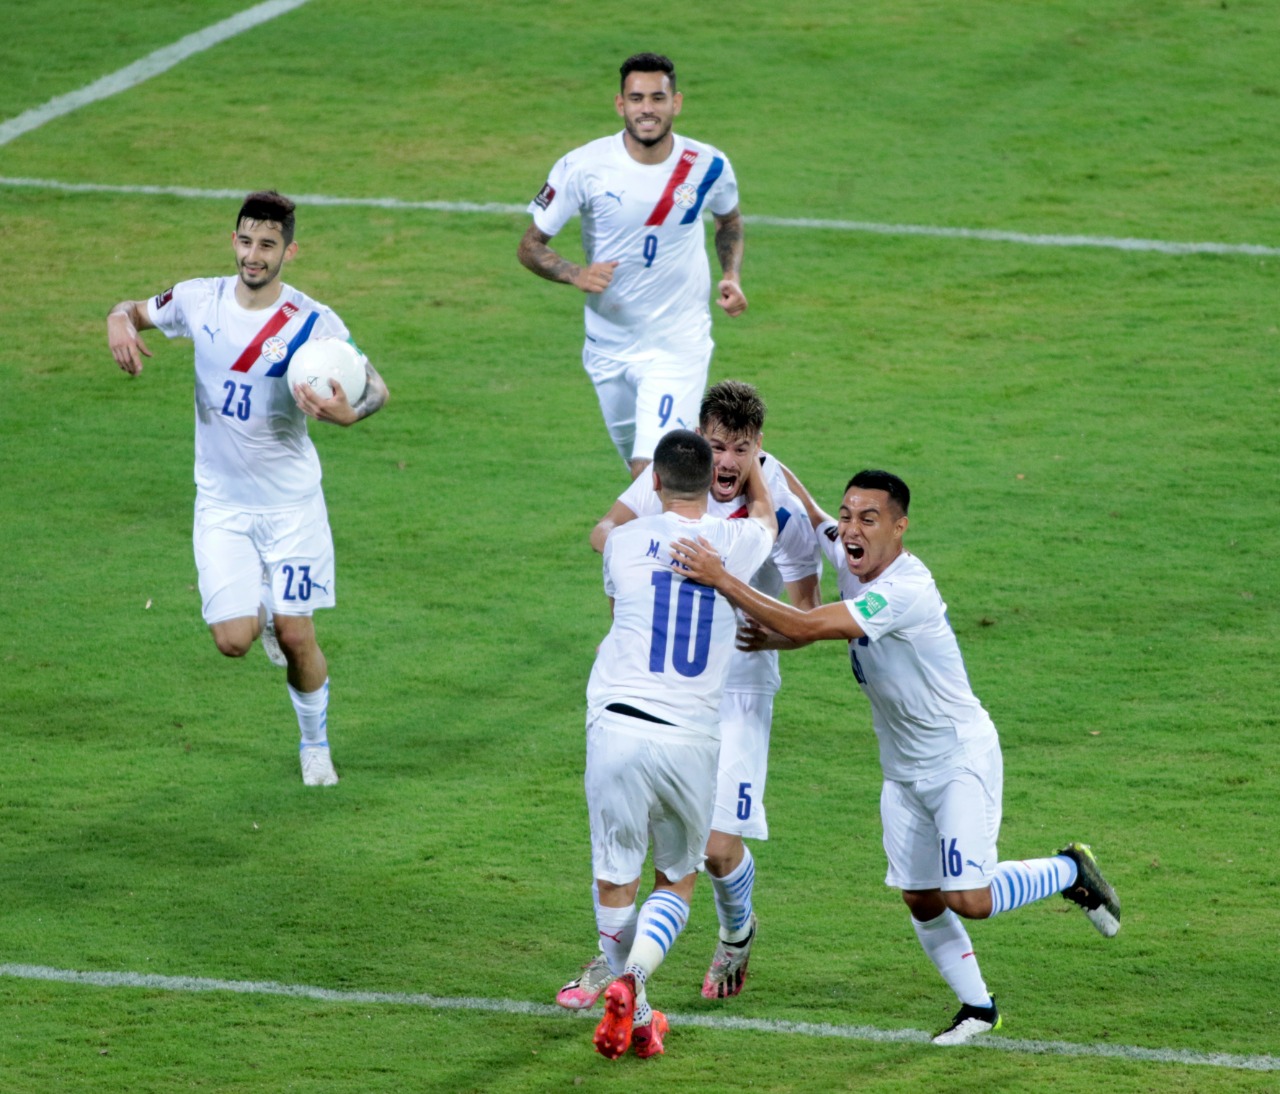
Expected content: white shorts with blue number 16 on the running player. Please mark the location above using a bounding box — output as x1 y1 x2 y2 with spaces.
881 746 1005 892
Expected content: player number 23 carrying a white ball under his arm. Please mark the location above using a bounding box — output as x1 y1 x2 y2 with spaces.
106 191 387 786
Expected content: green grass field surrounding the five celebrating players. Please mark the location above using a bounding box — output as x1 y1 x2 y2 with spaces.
0 0 1280 1094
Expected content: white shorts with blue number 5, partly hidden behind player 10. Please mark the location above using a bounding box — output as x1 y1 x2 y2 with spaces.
712 691 773 839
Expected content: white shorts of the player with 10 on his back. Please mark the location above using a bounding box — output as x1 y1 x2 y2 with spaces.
585 711 719 885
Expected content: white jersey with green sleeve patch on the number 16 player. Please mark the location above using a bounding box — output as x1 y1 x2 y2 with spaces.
818 521 998 782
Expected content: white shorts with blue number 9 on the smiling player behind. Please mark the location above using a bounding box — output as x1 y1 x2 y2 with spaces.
582 342 712 463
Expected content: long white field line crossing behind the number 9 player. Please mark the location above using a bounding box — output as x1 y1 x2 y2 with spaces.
0 175 1280 256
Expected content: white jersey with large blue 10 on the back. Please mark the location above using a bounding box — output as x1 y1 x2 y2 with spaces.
586 513 771 740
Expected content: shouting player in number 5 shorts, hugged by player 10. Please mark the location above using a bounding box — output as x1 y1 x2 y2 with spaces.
556 380 822 1010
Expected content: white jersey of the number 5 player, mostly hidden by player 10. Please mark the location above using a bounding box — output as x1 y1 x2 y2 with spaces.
611 453 820 695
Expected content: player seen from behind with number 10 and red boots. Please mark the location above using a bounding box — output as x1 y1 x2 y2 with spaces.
585 430 777 1059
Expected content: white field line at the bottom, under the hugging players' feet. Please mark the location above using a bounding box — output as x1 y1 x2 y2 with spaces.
0 965 1280 1071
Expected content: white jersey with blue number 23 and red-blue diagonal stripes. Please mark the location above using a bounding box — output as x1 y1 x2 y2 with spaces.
147 276 348 511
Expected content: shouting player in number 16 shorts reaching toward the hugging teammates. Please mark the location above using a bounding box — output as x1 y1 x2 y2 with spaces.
672 471 1120 1045
